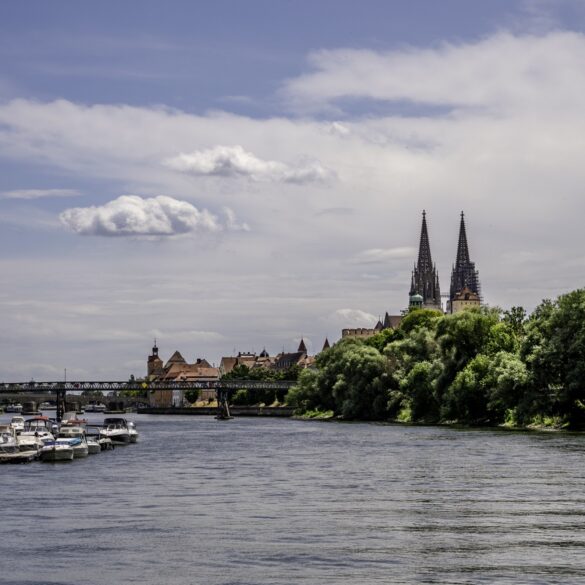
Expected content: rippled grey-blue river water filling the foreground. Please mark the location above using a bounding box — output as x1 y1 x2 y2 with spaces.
0 415 585 585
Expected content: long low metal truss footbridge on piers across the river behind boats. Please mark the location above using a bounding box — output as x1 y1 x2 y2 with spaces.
0 380 296 420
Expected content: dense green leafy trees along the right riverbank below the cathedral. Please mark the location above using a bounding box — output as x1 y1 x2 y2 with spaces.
286 289 585 428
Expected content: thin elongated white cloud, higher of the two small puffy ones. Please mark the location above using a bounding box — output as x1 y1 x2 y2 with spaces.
163 145 332 184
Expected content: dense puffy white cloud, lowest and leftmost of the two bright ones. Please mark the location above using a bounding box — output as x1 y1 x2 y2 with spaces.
60 195 221 236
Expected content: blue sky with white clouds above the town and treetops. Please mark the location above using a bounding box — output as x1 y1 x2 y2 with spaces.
0 0 585 382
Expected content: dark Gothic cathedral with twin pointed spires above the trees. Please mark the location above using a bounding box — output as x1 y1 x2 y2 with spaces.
409 211 481 313
